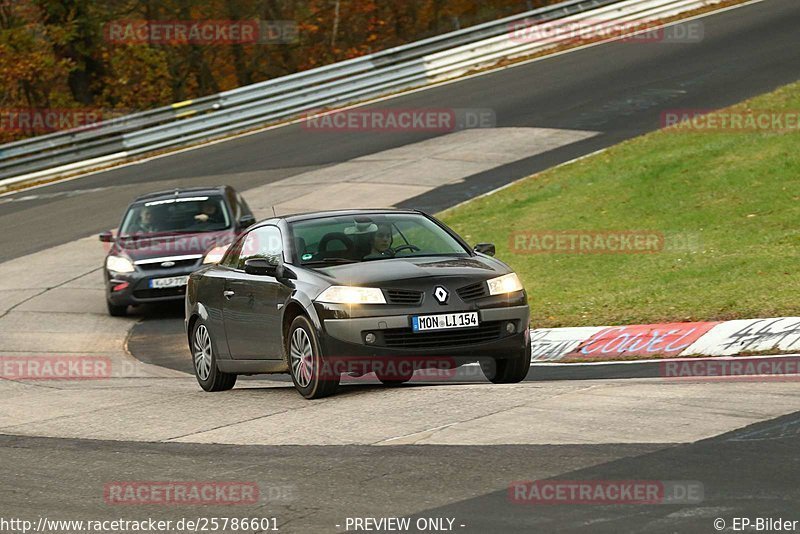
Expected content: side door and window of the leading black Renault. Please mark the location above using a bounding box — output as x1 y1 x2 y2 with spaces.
223 226 284 360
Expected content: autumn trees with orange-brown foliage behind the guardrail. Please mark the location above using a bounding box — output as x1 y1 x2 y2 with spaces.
0 0 555 142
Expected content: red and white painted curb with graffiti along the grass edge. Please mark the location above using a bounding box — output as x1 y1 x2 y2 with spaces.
531 317 800 361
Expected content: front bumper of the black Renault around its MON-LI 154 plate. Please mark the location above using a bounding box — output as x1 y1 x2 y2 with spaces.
321 305 530 364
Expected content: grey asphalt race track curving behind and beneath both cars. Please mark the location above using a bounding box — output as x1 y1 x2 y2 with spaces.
0 0 800 534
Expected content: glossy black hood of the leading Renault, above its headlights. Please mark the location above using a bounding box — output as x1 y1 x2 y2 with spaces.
316 256 511 286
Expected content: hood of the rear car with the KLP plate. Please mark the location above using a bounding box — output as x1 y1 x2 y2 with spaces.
112 230 235 261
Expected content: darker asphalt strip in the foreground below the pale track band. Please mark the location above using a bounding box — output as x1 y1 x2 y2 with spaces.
0 412 800 533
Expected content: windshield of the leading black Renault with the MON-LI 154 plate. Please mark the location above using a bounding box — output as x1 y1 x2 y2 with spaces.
290 213 469 265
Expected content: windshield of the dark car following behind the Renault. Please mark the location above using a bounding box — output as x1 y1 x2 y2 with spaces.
120 196 231 237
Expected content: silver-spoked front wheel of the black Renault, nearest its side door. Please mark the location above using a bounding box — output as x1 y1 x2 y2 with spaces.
284 315 341 400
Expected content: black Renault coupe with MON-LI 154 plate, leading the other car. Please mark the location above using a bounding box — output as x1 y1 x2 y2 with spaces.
186 210 530 399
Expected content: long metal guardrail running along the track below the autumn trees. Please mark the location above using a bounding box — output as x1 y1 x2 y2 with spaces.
0 0 720 185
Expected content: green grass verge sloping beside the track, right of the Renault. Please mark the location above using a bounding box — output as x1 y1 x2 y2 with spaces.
439 83 800 327
